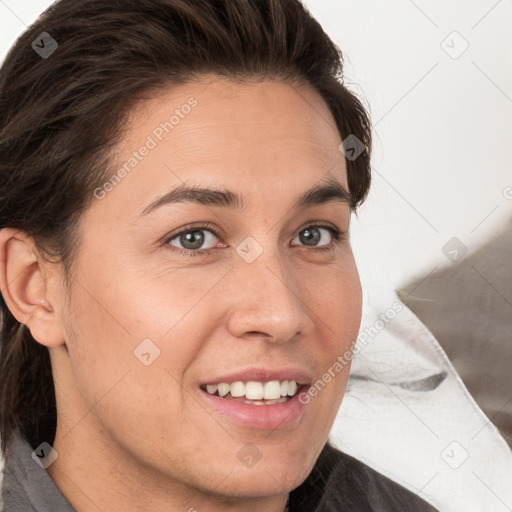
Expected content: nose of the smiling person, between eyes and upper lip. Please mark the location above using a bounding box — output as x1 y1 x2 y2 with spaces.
228 243 313 343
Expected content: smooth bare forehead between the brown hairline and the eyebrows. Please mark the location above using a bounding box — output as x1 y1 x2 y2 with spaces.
92 78 347 218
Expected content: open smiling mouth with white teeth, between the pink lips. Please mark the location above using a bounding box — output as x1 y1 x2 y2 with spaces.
200 380 307 405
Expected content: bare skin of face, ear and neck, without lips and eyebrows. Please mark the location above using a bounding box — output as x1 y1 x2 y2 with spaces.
0 77 361 512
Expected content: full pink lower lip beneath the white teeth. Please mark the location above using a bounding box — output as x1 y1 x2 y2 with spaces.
199 388 306 430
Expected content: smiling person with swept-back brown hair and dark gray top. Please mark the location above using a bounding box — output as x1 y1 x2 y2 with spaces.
0 0 434 512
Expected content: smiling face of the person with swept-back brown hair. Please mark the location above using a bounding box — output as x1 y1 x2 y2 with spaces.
47 78 361 506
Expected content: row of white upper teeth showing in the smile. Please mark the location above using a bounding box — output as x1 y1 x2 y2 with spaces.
206 380 297 400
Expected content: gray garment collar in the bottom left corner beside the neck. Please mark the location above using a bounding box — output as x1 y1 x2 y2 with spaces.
2 437 76 512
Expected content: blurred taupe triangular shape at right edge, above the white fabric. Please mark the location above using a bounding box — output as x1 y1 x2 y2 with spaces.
398 217 512 447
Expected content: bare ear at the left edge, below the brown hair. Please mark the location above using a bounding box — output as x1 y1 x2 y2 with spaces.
0 228 65 347
